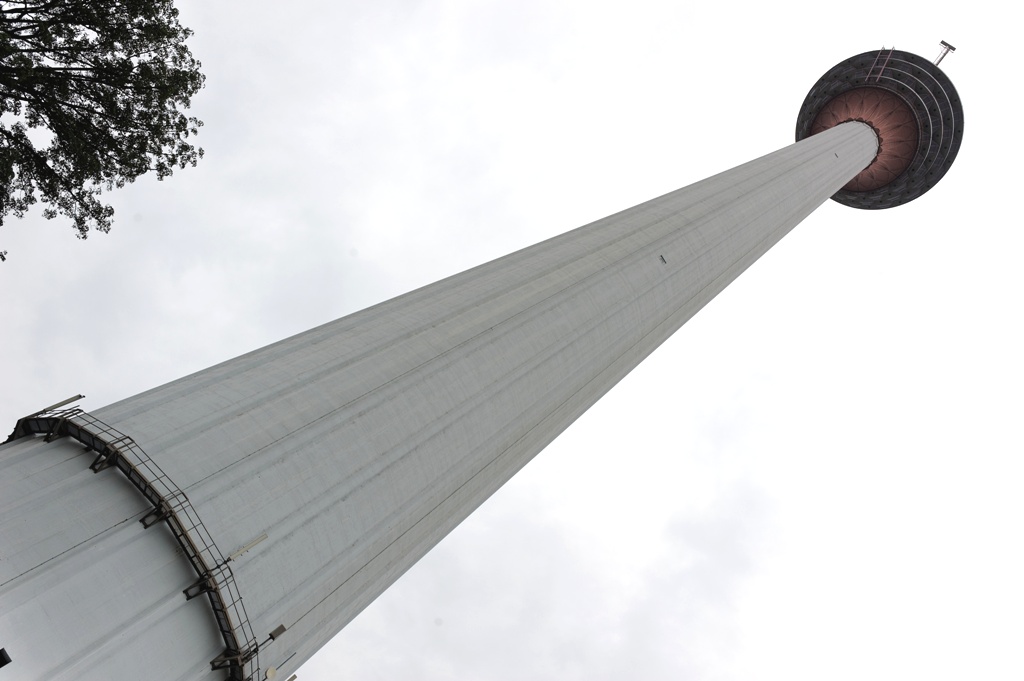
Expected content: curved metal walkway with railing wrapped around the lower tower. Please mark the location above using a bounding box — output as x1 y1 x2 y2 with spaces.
6 408 259 681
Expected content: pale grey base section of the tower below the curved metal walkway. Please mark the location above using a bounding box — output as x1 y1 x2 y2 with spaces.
0 437 224 681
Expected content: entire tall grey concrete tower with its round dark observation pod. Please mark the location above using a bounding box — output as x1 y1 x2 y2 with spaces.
0 43 964 681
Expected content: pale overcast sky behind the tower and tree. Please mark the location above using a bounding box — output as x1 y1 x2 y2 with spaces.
0 0 1024 681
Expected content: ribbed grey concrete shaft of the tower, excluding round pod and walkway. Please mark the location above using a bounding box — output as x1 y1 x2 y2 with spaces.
0 122 879 681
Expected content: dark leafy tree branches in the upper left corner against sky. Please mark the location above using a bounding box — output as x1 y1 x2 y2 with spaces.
0 0 206 239
